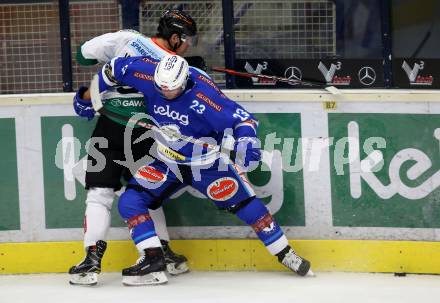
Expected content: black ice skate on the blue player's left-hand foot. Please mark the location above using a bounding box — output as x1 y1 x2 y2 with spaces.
122 247 168 286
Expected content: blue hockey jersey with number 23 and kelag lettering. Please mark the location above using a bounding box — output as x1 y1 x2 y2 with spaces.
99 57 258 164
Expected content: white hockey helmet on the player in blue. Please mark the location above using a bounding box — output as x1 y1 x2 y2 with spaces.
154 55 189 99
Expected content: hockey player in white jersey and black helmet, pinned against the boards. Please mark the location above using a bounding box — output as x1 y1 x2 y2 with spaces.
69 10 197 285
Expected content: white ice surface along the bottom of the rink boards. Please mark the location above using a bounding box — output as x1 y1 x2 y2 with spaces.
0 272 440 303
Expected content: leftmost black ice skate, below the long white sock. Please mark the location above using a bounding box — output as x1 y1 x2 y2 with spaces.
69 240 107 285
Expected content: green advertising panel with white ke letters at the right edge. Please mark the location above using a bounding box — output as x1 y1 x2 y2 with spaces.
328 113 440 228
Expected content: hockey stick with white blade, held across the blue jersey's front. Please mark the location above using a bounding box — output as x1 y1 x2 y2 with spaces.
90 75 220 151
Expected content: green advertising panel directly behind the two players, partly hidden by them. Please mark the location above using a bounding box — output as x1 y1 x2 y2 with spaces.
41 113 305 228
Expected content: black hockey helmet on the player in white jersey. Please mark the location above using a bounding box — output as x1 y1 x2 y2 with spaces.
157 9 197 45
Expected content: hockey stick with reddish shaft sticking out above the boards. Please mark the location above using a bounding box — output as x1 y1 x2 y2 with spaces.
211 67 340 95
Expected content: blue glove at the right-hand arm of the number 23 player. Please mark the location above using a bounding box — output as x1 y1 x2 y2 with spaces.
234 137 261 171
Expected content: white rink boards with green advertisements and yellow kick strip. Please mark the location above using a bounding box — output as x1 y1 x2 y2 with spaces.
0 90 440 273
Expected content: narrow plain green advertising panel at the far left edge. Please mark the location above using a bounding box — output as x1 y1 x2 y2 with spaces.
0 118 20 230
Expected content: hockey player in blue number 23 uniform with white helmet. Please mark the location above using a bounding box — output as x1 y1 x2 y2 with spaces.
99 55 312 285
